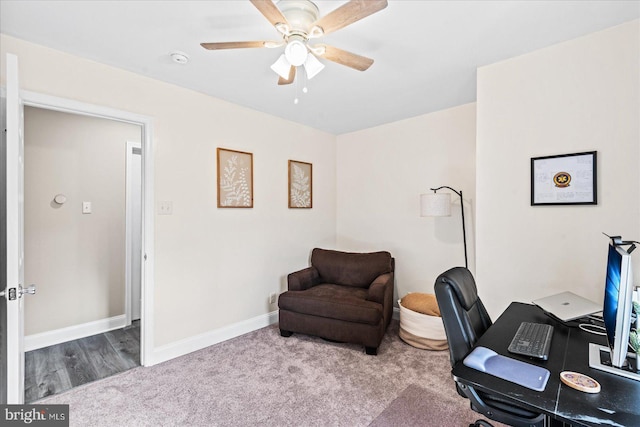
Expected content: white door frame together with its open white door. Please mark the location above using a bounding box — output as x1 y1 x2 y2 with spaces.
0 78 155 403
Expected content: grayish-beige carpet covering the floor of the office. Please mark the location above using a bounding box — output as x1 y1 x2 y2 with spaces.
37 321 498 427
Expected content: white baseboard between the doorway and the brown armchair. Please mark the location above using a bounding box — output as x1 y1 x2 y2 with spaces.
151 311 278 366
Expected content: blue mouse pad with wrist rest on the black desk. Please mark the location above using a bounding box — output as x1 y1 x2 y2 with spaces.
462 347 550 391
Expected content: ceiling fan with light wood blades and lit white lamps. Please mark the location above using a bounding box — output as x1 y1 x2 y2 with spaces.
200 0 387 85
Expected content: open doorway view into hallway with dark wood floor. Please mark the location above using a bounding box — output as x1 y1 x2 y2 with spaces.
24 106 142 402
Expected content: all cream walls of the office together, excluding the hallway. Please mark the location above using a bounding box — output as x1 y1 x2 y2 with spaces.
0 21 640 360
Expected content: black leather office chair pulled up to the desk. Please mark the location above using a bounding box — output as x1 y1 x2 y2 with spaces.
434 267 545 427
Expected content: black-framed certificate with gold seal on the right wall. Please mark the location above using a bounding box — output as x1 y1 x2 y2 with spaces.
531 151 598 206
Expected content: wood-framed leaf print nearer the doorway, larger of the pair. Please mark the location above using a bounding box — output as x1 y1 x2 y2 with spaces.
217 148 253 208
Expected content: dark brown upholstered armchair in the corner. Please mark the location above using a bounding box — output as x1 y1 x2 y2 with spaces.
278 248 395 355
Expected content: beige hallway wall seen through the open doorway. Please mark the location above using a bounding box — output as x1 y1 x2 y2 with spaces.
24 107 141 335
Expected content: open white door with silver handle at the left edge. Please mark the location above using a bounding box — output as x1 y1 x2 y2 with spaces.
3 54 28 404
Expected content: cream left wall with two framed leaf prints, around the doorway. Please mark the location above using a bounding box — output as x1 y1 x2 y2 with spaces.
0 35 336 352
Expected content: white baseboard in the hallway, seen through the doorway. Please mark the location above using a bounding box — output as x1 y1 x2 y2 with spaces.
24 314 127 351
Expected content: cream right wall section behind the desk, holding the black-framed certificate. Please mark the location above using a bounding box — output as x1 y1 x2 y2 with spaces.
476 20 640 317
